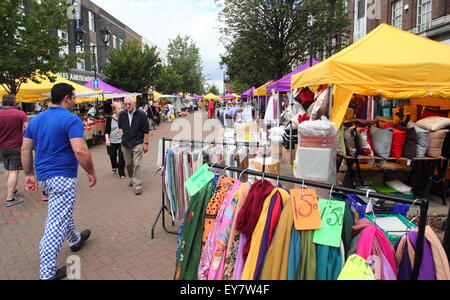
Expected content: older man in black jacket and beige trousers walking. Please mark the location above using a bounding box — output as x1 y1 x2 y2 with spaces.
119 98 150 195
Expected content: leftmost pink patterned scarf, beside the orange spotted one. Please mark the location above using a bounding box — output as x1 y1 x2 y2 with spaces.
197 181 241 280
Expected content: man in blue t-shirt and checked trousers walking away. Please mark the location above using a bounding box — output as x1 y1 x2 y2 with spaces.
22 83 97 280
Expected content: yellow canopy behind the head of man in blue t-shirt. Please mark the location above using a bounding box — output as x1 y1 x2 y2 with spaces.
0 74 99 103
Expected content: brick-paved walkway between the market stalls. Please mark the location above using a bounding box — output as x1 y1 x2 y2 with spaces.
0 110 218 280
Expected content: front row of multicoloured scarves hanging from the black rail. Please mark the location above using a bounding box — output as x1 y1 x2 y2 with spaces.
173 163 450 280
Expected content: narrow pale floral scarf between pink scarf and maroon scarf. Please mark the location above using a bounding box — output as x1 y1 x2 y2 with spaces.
222 184 250 280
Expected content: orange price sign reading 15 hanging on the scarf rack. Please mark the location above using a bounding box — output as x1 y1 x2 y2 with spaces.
291 189 322 230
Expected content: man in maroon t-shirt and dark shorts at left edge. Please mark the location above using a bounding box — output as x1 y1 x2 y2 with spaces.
0 95 28 207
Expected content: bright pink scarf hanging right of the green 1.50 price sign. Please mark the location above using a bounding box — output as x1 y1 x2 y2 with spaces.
356 225 397 274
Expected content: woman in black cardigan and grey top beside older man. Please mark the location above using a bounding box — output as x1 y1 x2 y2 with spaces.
105 102 125 179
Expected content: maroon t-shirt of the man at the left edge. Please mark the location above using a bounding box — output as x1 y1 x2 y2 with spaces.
0 107 29 149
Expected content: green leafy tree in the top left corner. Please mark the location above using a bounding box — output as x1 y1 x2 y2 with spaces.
0 0 77 94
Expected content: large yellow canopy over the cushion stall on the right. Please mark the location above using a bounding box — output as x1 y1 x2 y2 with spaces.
291 24 450 126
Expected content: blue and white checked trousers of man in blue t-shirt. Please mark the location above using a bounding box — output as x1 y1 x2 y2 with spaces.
39 177 81 280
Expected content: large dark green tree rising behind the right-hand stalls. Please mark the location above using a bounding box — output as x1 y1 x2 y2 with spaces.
220 0 349 90
